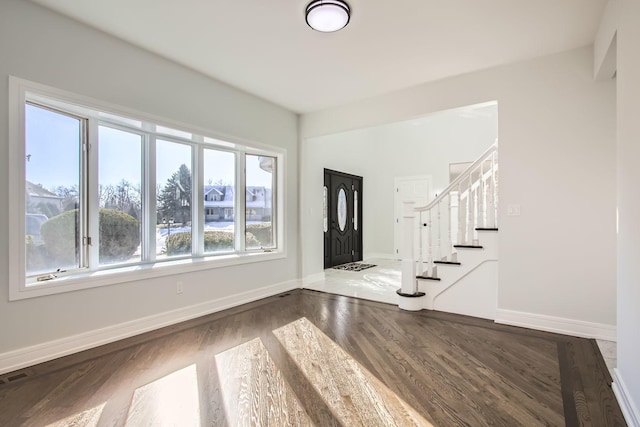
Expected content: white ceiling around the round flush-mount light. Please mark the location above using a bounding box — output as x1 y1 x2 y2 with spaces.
33 0 606 113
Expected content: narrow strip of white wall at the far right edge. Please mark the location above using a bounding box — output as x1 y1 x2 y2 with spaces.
595 0 640 426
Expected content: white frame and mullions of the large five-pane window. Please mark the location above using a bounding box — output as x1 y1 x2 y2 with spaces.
8 76 287 301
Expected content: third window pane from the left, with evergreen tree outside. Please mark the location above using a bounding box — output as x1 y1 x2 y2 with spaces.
156 140 192 259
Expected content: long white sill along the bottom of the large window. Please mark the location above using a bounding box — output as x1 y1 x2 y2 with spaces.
9 250 286 301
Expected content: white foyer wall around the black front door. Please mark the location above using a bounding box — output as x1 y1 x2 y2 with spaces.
301 104 498 262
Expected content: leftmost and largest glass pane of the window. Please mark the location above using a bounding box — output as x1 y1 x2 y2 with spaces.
25 104 83 276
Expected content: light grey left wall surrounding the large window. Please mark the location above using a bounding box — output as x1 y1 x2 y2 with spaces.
0 0 298 356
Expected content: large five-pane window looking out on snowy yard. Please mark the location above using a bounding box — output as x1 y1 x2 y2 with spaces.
12 80 283 298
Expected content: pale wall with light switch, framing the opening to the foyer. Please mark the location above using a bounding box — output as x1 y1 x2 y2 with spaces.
301 47 616 332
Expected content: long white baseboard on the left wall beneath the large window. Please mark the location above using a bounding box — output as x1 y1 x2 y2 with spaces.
0 280 300 374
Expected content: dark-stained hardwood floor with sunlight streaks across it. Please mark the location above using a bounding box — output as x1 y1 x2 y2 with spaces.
0 290 625 427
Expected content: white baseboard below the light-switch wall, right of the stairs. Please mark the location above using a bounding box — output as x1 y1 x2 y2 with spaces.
496 308 616 341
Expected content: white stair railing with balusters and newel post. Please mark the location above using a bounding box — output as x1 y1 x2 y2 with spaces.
412 141 498 277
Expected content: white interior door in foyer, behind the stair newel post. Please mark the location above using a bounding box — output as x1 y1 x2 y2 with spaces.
393 175 433 259
